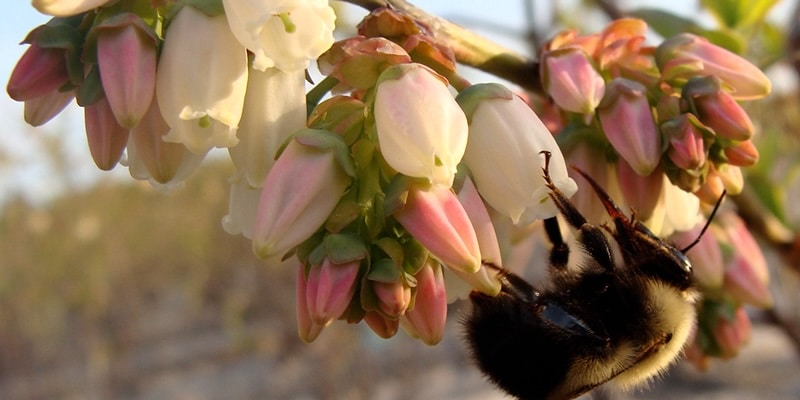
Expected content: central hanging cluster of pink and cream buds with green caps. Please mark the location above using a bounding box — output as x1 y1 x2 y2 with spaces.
284 9 577 344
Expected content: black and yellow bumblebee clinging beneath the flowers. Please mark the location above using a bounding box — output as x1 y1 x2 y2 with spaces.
465 153 697 399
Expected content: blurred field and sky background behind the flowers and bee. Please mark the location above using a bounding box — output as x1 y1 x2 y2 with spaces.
0 0 800 399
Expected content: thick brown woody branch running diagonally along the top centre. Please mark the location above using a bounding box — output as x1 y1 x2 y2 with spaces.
343 0 542 93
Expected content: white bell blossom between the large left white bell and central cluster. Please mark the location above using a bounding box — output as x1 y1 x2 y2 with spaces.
228 68 306 187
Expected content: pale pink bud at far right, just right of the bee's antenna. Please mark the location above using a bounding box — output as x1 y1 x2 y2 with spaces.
717 213 772 308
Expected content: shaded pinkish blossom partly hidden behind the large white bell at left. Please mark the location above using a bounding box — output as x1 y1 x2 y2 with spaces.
127 96 205 184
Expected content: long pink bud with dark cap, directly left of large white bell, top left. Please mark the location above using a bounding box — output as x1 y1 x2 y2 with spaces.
95 13 157 128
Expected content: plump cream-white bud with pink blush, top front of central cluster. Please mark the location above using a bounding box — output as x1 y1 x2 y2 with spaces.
374 64 468 187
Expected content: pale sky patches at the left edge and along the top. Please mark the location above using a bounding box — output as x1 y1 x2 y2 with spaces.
0 0 793 206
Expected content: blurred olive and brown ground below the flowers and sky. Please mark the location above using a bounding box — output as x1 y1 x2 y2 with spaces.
0 162 800 400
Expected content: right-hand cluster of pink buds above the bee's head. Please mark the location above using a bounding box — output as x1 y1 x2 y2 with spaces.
540 19 770 234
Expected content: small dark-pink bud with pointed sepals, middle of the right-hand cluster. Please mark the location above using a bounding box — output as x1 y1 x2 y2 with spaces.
661 114 713 170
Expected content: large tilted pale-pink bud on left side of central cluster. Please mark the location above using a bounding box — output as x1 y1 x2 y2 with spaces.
253 129 352 258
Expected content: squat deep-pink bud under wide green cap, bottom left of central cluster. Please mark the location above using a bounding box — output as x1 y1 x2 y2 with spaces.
306 257 361 326
